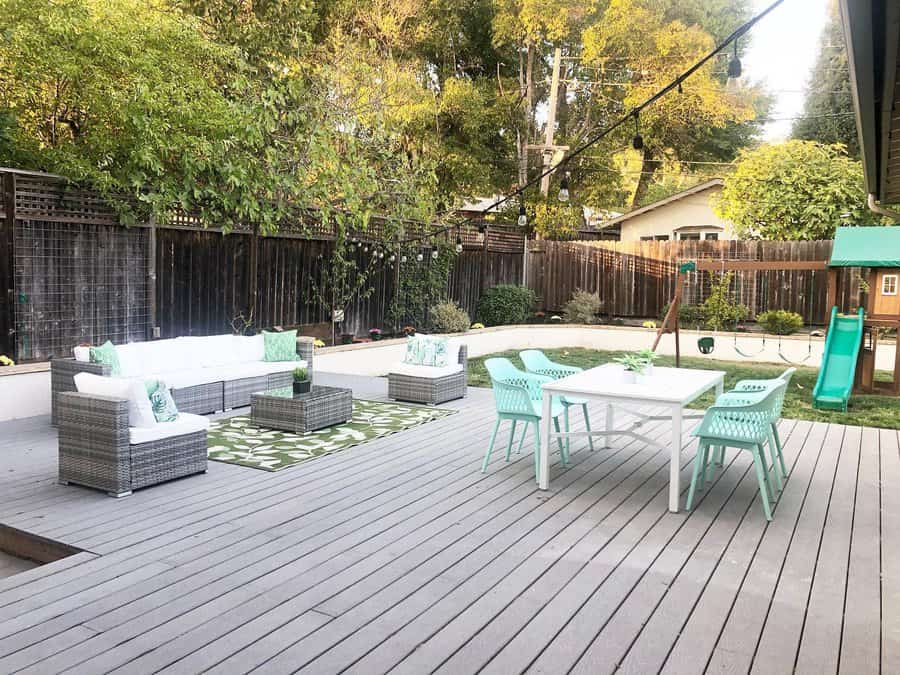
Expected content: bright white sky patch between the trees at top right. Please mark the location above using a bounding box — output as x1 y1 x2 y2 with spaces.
741 0 829 141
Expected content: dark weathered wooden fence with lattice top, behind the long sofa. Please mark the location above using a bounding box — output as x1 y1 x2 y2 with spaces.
0 170 524 360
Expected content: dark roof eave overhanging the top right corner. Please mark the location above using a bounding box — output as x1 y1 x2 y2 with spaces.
840 0 900 204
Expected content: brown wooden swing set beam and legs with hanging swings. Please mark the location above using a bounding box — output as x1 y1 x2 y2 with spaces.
653 259 828 367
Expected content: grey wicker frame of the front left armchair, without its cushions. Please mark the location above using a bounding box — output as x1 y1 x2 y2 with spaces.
57 392 207 497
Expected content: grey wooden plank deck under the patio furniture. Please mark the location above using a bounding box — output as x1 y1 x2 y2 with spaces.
0 378 900 674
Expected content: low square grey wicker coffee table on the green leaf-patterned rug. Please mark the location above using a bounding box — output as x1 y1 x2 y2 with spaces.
250 385 353 434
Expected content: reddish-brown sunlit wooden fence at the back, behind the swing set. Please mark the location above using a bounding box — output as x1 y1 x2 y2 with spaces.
527 241 859 324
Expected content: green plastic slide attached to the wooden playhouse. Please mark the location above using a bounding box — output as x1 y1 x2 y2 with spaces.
813 307 864 412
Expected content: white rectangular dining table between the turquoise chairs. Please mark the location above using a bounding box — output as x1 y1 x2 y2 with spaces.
538 363 725 511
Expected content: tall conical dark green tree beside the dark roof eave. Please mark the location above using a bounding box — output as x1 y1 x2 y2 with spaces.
792 0 859 157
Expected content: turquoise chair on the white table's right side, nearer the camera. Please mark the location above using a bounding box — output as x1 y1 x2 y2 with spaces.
687 383 785 520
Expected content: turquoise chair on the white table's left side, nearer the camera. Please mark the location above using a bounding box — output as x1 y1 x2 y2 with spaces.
481 358 569 480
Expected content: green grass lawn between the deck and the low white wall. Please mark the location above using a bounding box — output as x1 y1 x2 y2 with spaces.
469 348 900 429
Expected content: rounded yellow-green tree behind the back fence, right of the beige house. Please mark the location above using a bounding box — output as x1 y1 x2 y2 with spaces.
714 141 878 240
